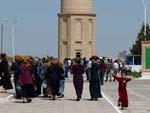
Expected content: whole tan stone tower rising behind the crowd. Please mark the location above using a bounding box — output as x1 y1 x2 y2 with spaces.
58 0 96 61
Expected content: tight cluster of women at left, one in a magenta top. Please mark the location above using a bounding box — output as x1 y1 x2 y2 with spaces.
5 56 64 103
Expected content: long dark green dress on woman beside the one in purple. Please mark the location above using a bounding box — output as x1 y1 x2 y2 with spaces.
90 63 102 98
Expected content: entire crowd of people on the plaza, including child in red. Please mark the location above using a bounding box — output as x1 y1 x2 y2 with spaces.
0 54 134 108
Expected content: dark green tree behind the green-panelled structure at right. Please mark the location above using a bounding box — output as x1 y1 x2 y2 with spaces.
130 24 150 55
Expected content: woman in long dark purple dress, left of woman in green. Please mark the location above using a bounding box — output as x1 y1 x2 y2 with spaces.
71 58 84 101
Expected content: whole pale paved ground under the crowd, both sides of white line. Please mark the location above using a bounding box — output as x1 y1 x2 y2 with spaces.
0 80 150 113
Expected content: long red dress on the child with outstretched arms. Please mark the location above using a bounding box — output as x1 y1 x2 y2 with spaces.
114 76 131 107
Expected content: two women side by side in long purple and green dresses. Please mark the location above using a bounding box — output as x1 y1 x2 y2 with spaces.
71 57 102 101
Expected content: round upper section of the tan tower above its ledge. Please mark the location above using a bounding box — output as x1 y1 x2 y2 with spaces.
61 0 93 14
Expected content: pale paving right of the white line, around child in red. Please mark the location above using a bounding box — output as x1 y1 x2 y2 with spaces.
103 80 150 113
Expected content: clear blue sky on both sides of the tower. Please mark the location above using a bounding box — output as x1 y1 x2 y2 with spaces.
0 0 150 57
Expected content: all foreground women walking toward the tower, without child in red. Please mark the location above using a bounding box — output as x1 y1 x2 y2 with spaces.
0 54 102 103
